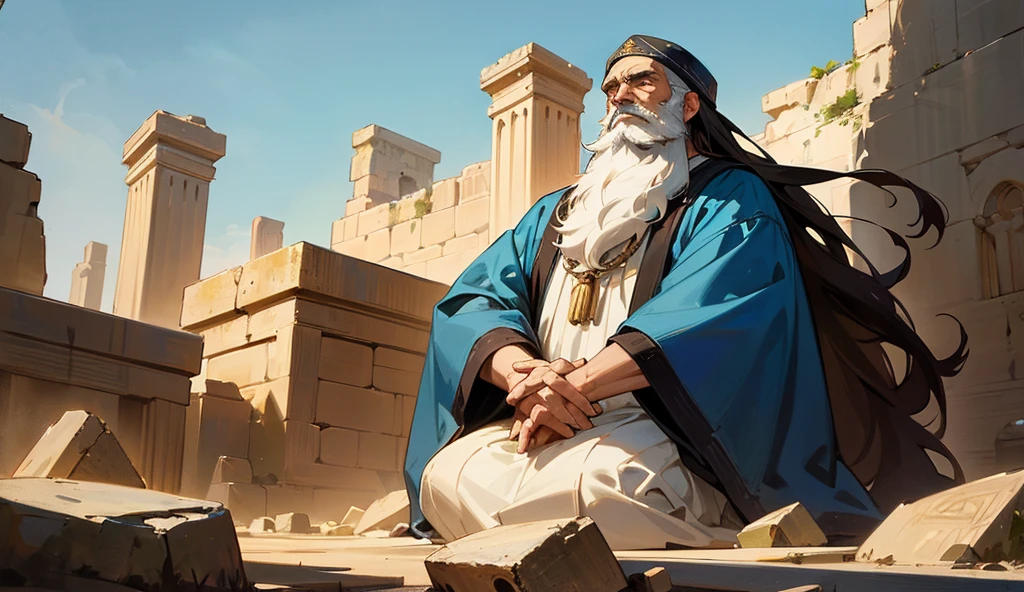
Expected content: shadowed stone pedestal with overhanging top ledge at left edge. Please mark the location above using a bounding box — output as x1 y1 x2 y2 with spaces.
0 288 203 493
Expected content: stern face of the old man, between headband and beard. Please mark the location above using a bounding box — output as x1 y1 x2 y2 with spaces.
601 55 672 129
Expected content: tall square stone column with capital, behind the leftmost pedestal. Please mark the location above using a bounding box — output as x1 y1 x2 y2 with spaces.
114 111 227 329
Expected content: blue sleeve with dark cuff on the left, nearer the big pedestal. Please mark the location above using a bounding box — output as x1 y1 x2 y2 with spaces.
404 189 565 527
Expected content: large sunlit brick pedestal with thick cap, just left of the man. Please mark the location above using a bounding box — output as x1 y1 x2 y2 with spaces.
181 243 447 521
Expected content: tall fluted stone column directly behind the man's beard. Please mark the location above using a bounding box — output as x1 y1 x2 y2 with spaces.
480 43 593 239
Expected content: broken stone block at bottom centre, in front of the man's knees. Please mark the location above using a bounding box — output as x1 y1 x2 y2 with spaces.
424 517 627 592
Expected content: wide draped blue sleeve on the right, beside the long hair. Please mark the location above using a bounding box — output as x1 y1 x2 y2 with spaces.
612 169 880 536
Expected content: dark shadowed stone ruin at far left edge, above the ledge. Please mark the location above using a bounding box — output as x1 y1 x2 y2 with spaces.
0 116 46 296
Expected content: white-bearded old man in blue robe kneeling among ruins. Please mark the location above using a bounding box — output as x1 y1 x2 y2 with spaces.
406 35 966 549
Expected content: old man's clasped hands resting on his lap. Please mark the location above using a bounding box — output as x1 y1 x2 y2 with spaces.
505 358 601 454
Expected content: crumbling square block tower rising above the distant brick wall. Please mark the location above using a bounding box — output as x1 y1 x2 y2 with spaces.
345 124 441 210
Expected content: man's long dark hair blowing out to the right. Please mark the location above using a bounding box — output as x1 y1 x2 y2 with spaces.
688 98 968 512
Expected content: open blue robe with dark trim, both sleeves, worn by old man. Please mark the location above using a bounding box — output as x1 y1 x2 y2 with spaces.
406 159 881 542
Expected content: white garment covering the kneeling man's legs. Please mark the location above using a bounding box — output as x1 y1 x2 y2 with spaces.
420 406 742 550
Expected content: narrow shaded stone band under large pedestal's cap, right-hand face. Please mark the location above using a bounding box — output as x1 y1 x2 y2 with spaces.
296 300 430 352
